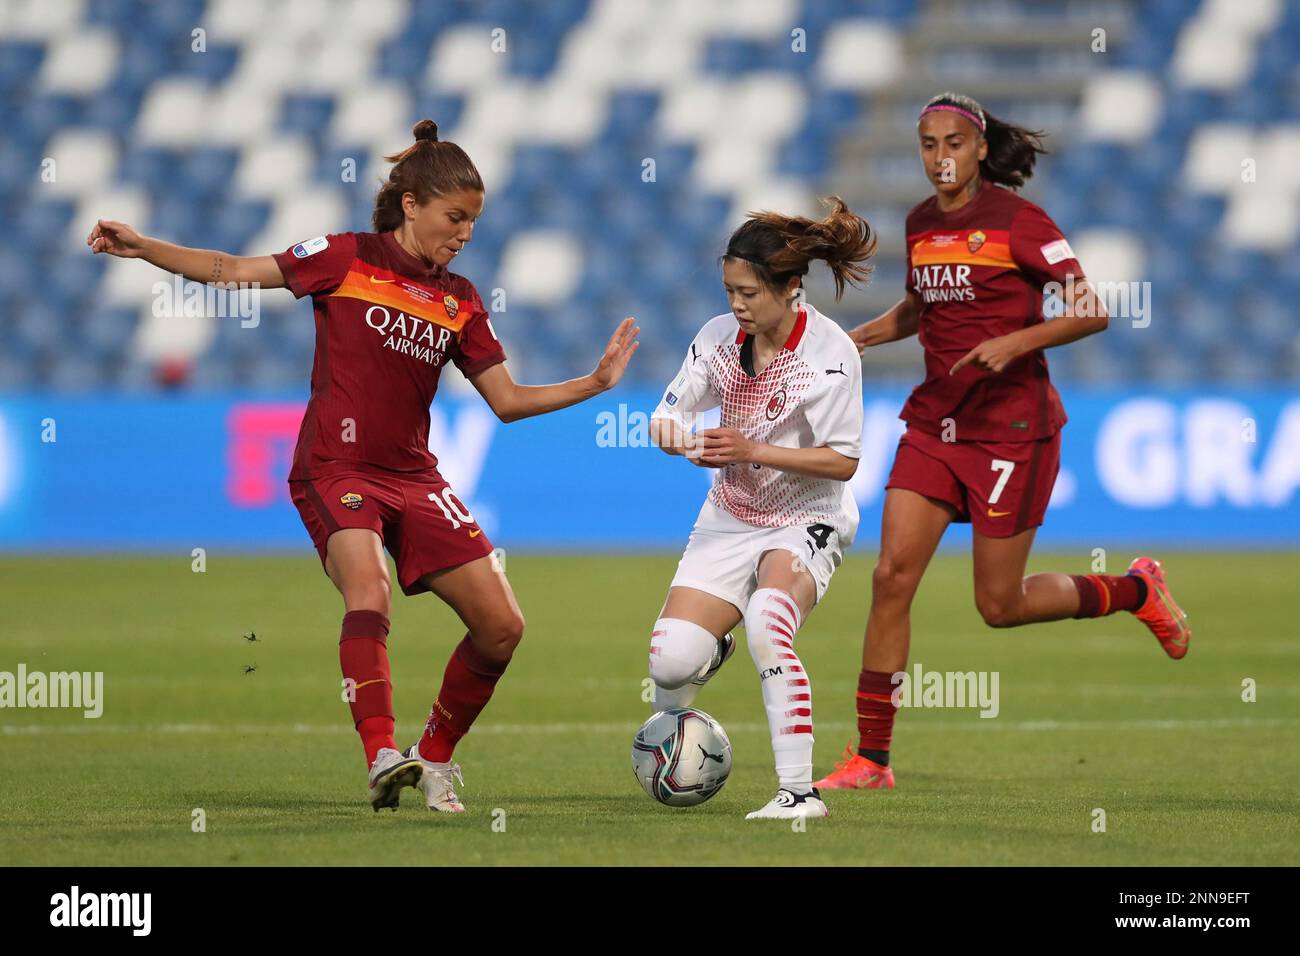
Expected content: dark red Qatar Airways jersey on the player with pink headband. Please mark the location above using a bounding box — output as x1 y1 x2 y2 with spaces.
900 182 1083 441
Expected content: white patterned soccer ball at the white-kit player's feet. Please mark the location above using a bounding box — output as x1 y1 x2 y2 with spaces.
632 708 731 806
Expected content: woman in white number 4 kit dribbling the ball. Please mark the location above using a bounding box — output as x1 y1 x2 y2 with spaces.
650 198 875 819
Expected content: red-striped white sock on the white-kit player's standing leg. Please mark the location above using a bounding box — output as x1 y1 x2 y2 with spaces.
745 588 813 793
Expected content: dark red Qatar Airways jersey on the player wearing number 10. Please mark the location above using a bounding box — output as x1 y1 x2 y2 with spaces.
276 233 506 481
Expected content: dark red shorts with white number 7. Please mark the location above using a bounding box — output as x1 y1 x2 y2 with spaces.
885 428 1061 537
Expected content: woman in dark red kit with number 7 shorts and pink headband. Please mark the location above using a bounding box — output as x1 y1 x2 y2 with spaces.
815 92 1192 790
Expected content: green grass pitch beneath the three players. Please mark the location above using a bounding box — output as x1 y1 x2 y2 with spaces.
0 553 1300 865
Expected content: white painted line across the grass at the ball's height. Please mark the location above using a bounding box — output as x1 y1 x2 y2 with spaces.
0 708 1300 736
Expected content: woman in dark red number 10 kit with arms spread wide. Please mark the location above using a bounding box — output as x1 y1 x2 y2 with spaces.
88 120 640 813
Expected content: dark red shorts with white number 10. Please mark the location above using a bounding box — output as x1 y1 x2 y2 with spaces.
289 472 493 594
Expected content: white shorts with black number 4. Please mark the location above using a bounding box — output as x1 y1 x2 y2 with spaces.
671 501 844 614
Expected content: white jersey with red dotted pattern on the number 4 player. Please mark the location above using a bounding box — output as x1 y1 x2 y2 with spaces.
653 304 862 548
